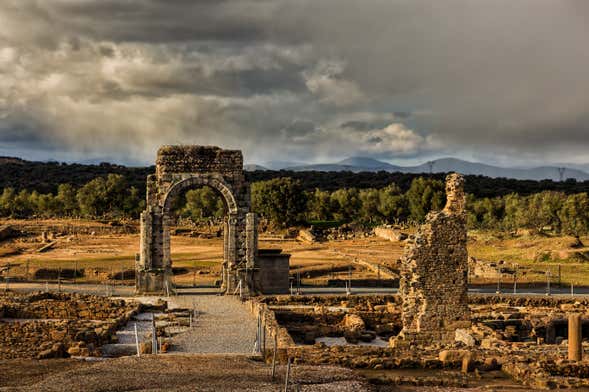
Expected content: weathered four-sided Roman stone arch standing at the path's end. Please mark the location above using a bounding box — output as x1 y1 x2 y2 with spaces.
136 146 257 293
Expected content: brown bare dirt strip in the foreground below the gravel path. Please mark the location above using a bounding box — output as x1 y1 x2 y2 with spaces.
0 355 372 392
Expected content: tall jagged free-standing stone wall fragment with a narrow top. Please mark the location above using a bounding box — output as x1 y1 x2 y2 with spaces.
393 174 470 345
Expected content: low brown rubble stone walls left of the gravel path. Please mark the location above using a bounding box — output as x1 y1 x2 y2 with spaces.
0 293 140 359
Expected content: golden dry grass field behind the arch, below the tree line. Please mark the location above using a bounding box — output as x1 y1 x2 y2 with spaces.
0 220 589 286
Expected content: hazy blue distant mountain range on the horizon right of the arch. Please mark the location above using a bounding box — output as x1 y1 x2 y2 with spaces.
245 157 589 181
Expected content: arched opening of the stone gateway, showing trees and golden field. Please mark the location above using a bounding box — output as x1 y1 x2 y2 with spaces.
162 177 237 290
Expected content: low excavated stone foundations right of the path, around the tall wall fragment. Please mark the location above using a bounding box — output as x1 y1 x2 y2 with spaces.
256 295 589 389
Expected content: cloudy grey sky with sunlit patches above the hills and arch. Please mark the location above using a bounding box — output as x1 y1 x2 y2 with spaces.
0 0 589 168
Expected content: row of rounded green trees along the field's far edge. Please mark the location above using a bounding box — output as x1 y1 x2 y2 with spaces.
0 174 589 237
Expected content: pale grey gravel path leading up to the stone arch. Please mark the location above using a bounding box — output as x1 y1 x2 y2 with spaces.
165 295 257 354
